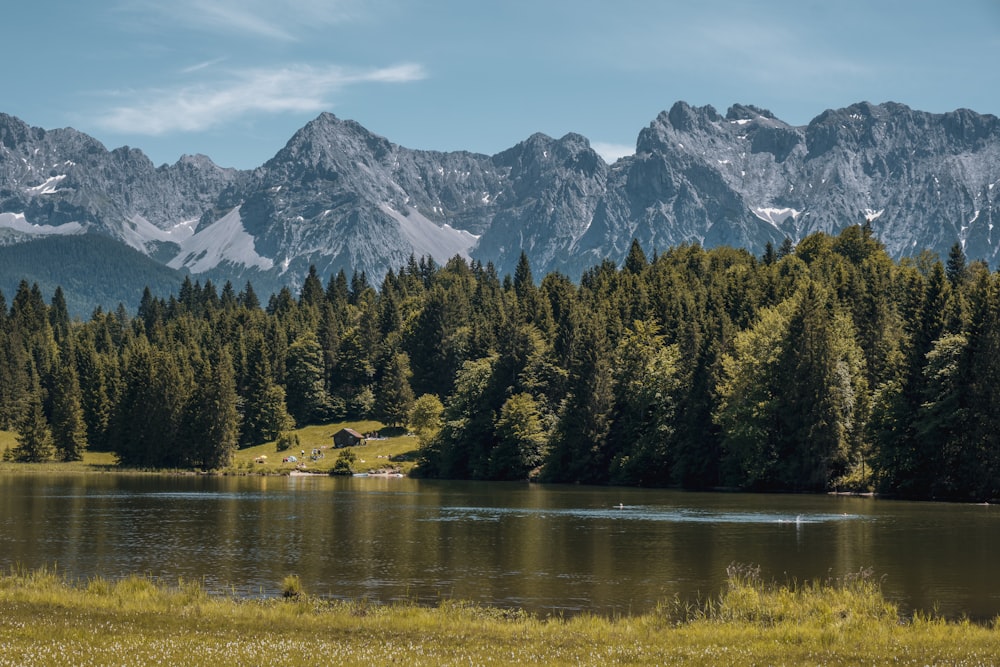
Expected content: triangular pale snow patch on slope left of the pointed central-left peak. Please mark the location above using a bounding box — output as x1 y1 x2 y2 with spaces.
167 206 274 273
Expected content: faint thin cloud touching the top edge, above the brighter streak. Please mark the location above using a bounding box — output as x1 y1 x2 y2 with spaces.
123 0 368 42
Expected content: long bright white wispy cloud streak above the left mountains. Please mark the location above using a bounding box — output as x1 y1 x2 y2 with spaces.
95 64 426 136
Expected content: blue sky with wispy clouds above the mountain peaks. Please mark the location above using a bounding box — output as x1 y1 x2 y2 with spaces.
0 0 1000 168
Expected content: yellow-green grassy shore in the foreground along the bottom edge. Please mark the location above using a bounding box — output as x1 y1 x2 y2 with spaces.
0 568 1000 666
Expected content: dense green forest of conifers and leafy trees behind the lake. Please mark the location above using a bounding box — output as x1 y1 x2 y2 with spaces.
0 225 1000 499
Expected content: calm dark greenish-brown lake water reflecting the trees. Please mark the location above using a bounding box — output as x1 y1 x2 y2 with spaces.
0 473 1000 619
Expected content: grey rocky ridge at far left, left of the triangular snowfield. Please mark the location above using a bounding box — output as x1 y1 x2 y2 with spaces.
0 114 241 255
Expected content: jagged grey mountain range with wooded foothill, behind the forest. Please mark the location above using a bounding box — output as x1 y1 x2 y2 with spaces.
0 102 1000 314
